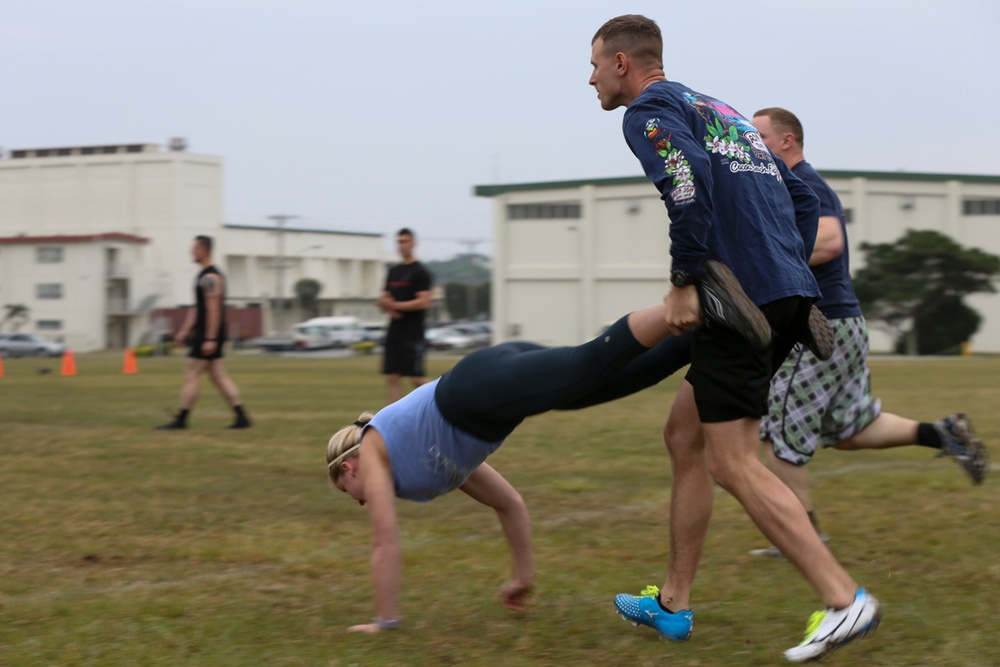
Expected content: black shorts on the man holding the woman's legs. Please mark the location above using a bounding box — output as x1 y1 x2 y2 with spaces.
685 296 814 423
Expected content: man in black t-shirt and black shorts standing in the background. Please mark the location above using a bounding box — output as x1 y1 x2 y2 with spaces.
378 227 432 404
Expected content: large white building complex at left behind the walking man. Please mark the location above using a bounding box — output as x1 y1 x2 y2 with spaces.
0 140 386 352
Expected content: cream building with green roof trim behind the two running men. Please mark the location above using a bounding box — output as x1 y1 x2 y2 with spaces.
475 171 1000 352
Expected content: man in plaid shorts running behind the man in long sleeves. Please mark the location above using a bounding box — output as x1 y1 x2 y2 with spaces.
750 107 989 558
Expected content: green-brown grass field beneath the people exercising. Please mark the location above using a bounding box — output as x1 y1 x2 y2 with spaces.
0 355 1000 667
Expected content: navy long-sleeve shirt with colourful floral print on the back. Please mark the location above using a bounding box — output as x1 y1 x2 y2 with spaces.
622 81 820 305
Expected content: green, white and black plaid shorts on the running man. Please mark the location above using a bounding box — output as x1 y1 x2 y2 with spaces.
760 317 882 465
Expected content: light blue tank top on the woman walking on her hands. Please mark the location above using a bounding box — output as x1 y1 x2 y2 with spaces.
362 380 503 502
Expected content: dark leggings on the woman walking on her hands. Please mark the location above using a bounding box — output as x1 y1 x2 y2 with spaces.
434 317 691 441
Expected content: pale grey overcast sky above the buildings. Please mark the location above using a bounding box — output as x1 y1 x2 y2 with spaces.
0 0 1000 259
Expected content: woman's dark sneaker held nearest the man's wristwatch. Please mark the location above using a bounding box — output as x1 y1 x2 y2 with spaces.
697 259 771 351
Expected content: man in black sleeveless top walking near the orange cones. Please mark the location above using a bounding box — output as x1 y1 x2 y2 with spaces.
156 236 250 431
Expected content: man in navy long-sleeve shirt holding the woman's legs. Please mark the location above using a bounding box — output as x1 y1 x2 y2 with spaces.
590 15 880 662
